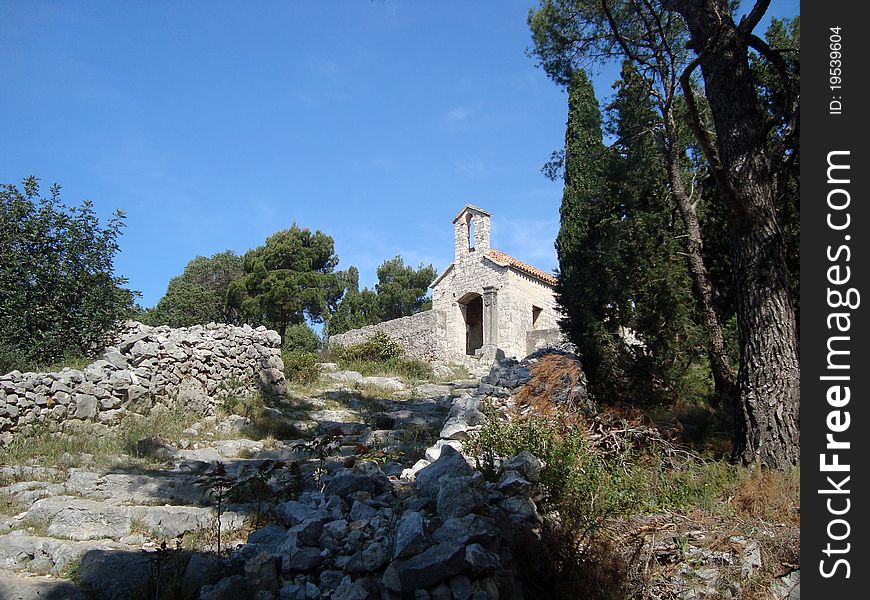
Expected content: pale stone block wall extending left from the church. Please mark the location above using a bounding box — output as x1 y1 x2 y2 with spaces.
329 310 446 361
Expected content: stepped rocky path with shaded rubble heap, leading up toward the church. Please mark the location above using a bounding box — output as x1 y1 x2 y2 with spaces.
0 371 534 599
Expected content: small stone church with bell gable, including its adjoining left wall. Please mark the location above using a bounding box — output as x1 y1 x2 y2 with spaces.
330 204 562 361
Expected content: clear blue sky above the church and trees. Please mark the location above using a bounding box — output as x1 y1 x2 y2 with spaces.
0 0 798 306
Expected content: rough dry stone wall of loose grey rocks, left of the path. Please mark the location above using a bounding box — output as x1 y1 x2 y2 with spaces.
0 322 285 445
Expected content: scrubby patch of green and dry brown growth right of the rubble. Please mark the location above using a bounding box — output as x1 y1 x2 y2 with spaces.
470 361 800 600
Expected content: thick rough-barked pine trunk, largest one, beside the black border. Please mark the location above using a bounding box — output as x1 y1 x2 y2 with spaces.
665 0 800 469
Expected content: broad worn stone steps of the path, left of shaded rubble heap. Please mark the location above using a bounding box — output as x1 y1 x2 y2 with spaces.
0 382 508 599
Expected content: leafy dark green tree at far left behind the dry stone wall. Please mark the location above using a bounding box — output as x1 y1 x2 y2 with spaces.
0 176 134 372
